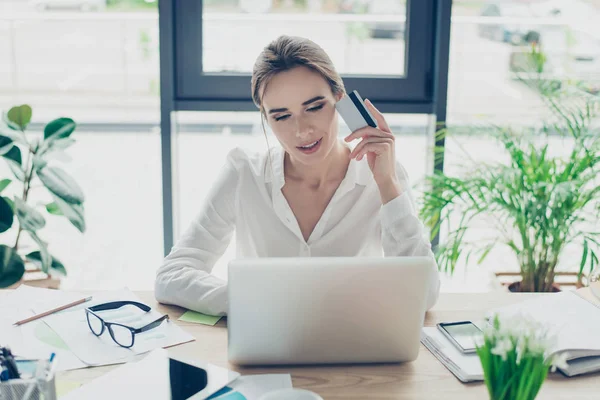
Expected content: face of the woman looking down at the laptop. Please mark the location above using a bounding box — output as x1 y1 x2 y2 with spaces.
262 67 339 165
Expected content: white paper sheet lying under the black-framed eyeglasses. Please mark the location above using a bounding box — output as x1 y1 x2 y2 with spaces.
45 290 194 366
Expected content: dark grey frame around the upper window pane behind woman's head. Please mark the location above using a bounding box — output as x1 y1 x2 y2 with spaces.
172 0 436 113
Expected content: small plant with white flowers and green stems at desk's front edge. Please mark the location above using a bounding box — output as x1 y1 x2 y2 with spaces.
477 316 568 400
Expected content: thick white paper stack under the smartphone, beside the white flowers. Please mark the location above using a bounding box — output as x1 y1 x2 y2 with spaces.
421 327 483 382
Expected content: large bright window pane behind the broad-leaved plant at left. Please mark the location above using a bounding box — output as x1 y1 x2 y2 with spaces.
0 0 163 290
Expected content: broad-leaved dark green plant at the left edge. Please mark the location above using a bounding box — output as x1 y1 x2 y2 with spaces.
0 105 85 287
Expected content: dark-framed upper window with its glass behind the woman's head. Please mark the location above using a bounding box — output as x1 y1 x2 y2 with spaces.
173 0 435 111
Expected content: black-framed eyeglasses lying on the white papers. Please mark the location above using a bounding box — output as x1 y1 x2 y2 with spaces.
85 301 169 348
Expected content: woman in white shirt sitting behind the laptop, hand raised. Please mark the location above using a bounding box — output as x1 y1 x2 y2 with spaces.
155 36 439 315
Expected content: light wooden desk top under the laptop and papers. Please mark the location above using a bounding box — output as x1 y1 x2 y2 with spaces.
58 292 600 400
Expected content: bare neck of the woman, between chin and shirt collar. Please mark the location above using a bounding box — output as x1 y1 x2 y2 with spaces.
284 140 350 189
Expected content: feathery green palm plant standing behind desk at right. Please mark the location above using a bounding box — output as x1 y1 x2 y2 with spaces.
421 80 600 292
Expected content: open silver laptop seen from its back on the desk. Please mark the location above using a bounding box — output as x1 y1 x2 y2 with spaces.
227 257 436 365
